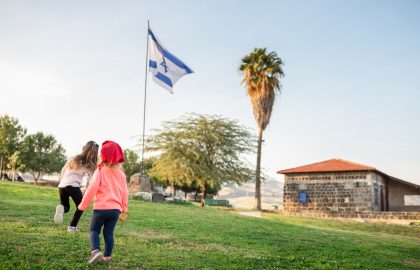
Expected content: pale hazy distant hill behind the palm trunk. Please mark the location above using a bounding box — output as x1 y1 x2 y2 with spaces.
217 179 283 209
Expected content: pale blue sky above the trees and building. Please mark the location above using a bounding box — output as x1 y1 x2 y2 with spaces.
0 0 420 184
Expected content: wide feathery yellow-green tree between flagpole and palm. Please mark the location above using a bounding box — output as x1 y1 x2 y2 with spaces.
146 114 256 206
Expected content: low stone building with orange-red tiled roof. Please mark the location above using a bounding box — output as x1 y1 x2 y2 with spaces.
278 159 420 216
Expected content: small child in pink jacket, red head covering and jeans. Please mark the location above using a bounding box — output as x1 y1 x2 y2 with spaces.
78 141 128 264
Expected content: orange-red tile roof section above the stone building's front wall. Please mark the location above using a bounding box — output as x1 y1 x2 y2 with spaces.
277 159 376 174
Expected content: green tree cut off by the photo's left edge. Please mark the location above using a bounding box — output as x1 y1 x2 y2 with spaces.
0 114 26 171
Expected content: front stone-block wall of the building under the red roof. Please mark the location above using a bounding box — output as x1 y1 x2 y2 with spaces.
283 172 374 213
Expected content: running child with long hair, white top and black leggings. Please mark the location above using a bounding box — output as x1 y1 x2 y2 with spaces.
54 141 99 232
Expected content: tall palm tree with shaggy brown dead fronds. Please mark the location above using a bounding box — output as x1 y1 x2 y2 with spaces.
239 48 284 210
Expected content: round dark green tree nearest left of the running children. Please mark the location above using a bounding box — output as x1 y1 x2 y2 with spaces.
20 132 66 184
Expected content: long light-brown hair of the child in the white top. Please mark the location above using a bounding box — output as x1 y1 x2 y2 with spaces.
68 141 99 172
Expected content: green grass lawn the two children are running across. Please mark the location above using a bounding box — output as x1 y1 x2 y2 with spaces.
0 182 420 269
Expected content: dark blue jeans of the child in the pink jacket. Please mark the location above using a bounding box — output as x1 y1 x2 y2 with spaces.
90 209 120 257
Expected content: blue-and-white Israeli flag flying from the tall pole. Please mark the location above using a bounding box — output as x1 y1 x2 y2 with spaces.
149 28 193 93
